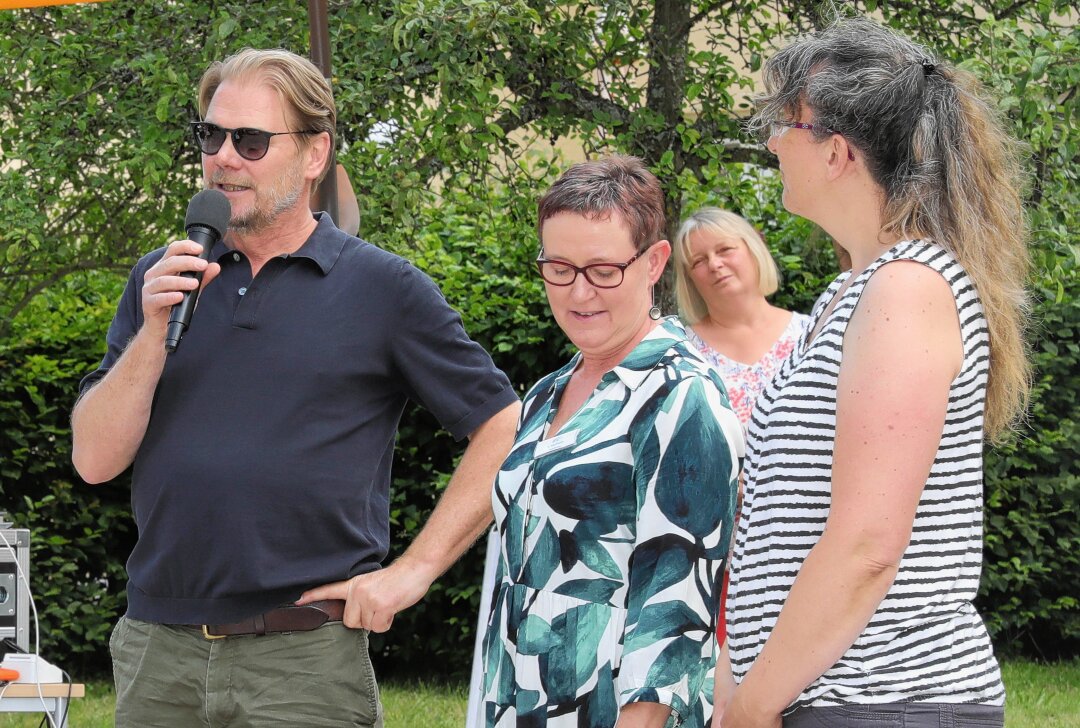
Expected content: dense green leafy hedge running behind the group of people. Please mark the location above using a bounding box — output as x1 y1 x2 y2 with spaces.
0 180 1080 676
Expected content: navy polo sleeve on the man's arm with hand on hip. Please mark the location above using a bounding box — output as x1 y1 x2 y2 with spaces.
390 261 517 440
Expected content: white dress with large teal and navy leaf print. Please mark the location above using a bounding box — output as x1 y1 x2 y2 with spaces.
484 318 743 728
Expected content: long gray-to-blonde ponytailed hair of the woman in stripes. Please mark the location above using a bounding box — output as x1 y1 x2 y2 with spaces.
751 18 1030 441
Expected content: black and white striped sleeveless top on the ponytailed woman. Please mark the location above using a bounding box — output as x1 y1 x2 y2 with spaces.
727 241 1004 710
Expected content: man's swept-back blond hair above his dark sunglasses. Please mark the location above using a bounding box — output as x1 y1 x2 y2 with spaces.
199 48 337 185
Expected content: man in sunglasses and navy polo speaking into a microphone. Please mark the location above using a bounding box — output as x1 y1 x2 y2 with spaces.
72 50 519 728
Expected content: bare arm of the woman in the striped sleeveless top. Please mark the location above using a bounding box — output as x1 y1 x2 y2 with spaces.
721 261 963 728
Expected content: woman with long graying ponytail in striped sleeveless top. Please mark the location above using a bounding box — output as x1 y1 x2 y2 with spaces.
721 12 1029 728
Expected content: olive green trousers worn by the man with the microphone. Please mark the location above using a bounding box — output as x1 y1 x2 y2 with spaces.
109 617 382 728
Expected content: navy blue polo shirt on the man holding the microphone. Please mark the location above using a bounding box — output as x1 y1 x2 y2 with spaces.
81 216 516 624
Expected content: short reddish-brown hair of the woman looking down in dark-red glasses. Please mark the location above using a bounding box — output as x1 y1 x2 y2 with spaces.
537 154 665 252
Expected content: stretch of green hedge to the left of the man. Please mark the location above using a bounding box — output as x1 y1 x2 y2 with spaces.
0 275 134 675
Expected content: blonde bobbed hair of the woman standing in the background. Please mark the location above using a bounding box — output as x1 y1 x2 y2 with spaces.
673 207 780 326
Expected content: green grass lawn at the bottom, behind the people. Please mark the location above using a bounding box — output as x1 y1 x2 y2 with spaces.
0 660 1080 728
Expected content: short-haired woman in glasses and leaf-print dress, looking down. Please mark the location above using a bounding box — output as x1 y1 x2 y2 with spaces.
484 157 742 728
